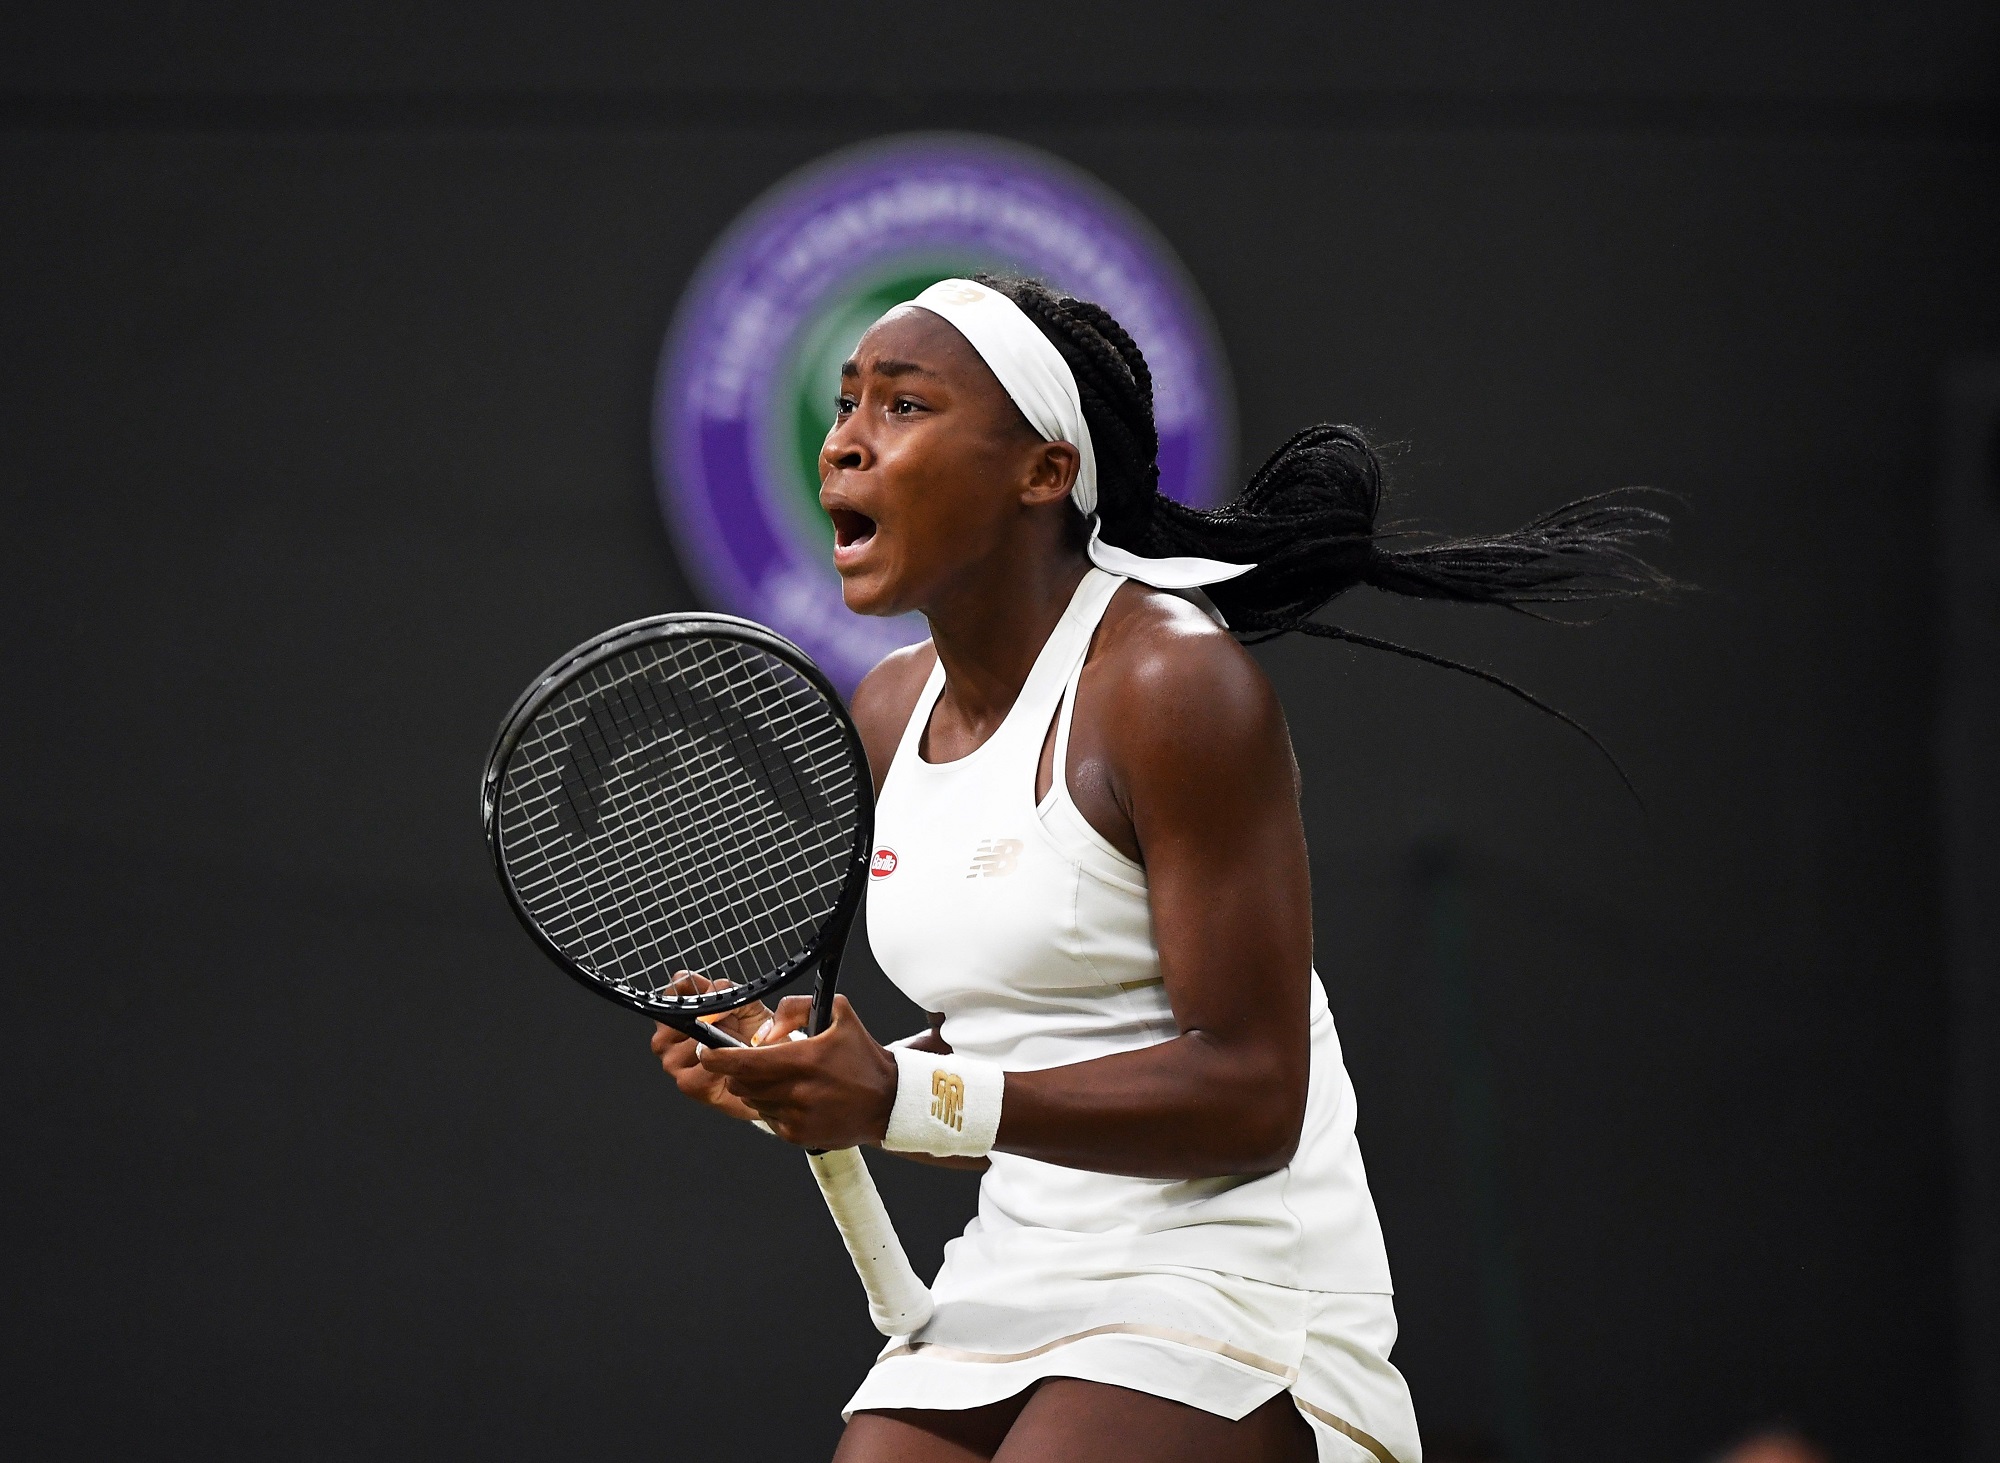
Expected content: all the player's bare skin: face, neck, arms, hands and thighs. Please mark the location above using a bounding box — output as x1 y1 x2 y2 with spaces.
652 308 1312 1463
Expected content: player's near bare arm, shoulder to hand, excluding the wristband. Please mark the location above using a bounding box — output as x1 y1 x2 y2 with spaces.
700 599 1312 1177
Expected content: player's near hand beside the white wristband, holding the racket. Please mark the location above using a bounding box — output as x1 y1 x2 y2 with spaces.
700 995 896 1149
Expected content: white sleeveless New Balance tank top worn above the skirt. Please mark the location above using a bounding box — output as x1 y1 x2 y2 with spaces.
868 570 1390 1293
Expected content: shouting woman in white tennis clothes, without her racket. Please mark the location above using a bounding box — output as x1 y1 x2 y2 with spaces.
652 278 1662 1463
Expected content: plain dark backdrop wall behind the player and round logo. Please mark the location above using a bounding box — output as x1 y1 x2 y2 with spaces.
0 0 2000 1463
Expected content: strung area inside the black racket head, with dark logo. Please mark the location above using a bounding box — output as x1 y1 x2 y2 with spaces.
502 638 860 1003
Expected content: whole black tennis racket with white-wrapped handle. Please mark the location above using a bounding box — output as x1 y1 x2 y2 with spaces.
480 614 932 1335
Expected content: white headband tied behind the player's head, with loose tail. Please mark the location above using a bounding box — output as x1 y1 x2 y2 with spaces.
904 280 1256 595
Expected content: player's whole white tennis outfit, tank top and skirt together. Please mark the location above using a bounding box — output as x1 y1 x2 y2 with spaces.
846 570 1420 1463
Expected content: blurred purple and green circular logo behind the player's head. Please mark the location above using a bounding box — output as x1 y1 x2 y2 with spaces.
654 134 1234 690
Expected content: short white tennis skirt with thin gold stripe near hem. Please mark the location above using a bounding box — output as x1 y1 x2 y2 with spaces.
842 1255 1422 1463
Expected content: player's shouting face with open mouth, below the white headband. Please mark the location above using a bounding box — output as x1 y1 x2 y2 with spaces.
820 306 1076 616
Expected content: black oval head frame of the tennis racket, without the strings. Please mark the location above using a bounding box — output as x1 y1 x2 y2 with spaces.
480 612 874 1047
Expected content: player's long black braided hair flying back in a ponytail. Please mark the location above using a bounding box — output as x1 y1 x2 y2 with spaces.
976 274 1676 787
